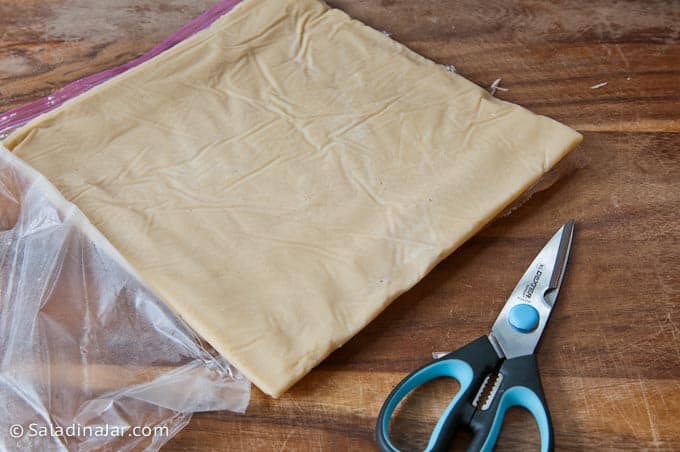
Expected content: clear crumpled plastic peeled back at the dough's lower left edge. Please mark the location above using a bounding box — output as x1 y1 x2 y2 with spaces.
0 146 250 451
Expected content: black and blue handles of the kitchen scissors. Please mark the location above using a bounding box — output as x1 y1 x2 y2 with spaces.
376 336 553 452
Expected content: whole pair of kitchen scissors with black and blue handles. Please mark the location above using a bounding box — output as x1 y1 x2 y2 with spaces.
376 220 574 452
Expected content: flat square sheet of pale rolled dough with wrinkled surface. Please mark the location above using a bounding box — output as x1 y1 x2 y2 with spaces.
5 0 581 397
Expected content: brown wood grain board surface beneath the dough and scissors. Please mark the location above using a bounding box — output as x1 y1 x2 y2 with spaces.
0 0 680 450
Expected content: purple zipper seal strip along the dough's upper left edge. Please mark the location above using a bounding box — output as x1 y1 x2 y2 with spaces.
0 0 241 139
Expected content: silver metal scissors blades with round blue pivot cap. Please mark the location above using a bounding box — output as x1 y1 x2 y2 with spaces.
489 220 574 359
